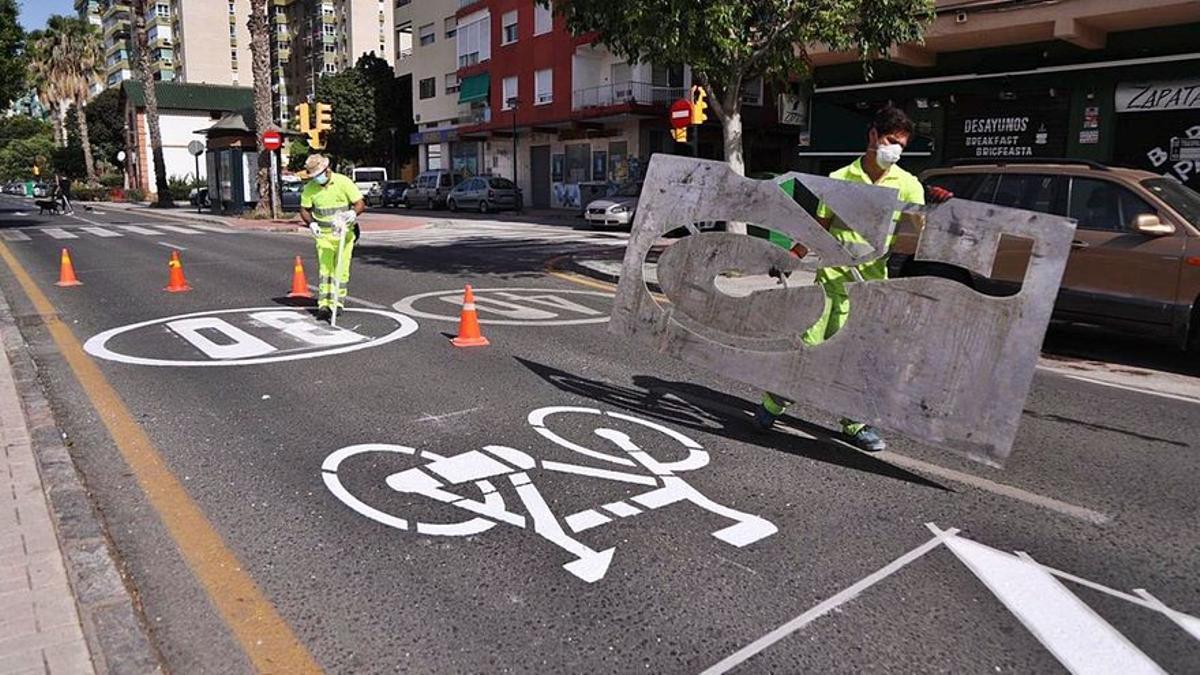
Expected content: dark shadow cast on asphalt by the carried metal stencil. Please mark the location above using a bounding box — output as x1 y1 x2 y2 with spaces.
515 357 953 491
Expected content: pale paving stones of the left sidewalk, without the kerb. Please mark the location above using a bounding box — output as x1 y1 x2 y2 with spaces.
0 350 95 674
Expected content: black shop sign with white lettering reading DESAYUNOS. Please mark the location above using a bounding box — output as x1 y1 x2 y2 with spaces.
946 97 1068 160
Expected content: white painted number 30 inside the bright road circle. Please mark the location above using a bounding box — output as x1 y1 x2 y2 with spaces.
167 311 365 360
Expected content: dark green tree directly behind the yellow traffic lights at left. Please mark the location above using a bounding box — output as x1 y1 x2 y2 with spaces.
317 68 377 163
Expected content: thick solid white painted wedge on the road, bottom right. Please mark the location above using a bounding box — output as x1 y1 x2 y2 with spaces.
946 537 1163 675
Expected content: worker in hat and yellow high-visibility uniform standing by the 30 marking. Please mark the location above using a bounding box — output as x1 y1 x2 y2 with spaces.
300 155 367 321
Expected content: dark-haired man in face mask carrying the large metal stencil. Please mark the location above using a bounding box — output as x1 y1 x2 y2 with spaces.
755 104 931 452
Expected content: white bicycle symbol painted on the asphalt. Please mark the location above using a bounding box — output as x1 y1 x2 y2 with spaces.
322 406 778 583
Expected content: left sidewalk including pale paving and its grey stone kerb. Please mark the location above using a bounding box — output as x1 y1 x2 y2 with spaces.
0 294 162 675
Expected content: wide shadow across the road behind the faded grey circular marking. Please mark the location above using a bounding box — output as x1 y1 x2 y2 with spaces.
354 237 611 279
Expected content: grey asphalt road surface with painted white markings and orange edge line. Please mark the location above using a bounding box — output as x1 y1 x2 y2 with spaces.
0 192 1200 673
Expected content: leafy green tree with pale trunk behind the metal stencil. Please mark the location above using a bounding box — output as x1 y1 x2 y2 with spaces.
552 0 934 174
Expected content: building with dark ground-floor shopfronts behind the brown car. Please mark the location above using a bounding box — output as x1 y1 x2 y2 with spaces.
797 0 1200 190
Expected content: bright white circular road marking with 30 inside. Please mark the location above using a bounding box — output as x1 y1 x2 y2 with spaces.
83 306 418 368
